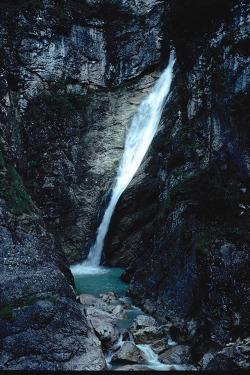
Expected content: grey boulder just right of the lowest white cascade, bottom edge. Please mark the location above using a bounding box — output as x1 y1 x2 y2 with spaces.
158 345 191 365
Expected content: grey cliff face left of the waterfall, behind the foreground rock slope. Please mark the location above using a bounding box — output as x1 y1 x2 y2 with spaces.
0 0 166 262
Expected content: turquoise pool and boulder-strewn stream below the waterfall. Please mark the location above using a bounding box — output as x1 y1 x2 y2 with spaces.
71 267 196 371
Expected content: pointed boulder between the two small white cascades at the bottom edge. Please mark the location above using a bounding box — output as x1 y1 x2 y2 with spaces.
111 341 147 363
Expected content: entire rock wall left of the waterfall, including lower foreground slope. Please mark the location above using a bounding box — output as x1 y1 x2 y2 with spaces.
0 0 168 370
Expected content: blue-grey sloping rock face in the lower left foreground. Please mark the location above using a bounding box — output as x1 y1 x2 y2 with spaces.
0 197 106 371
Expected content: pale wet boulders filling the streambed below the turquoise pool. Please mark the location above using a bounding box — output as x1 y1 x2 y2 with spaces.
79 292 196 371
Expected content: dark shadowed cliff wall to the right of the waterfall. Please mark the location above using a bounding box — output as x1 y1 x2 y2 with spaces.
106 1 250 366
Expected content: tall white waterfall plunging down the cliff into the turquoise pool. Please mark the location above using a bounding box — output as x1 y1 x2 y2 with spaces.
71 52 175 273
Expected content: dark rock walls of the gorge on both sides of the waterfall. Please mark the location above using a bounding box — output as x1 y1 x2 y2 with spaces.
0 0 250 371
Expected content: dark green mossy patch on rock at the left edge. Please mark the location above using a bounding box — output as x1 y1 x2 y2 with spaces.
0 167 31 215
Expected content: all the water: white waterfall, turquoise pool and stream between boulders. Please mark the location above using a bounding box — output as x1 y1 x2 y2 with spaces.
70 52 188 371
